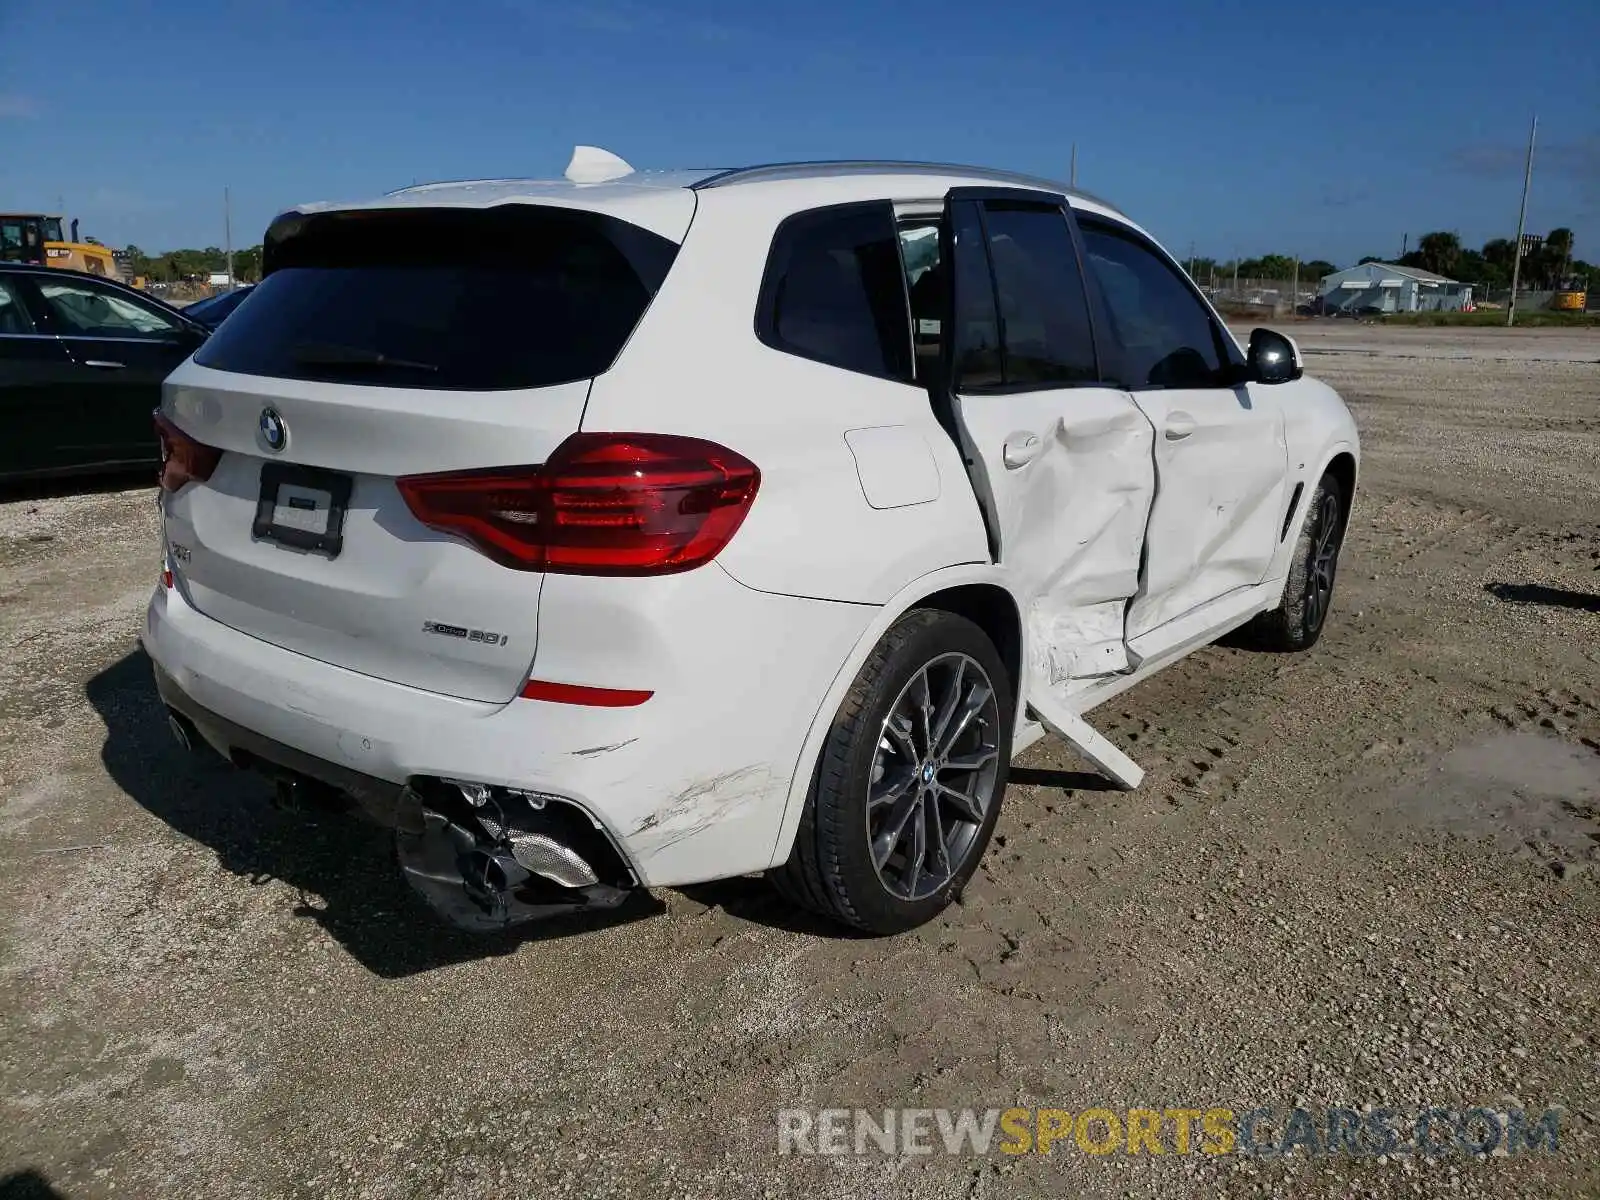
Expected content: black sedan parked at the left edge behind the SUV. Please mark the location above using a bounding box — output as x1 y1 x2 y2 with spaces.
0 262 210 478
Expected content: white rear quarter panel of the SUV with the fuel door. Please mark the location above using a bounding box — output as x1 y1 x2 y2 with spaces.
582 184 989 605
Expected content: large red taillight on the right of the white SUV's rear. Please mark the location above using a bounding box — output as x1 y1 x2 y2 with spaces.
397 434 762 574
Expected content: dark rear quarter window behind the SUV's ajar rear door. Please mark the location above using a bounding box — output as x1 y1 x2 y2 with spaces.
755 203 912 382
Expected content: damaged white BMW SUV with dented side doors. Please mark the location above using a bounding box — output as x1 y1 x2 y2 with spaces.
144 149 1358 933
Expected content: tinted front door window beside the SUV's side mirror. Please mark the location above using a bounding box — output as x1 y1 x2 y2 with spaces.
1078 219 1227 387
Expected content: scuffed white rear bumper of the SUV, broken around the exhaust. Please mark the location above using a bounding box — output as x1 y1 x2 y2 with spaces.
144 566 875 886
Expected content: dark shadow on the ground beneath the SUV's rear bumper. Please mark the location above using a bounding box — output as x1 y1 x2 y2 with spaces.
85 650 664 978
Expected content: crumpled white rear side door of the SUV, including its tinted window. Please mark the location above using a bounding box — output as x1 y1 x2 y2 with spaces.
946 189 1155 701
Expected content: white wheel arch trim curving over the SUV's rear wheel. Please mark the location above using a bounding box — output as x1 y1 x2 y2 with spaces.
770 563 1024 866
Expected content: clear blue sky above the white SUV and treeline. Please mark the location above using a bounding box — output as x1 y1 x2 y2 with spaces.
0 0 1600 264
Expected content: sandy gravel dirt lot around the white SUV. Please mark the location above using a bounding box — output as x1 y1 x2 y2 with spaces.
0 323 1600 1198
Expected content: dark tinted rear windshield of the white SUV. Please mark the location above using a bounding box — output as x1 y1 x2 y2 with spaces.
195 205 677 392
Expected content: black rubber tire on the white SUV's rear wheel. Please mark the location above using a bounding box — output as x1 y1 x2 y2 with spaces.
770 610 1016 934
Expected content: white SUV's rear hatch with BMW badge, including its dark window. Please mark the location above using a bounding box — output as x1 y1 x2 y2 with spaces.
162 194 693 701
